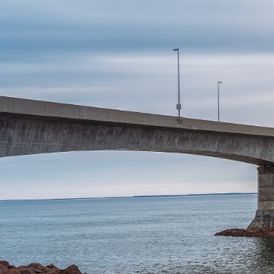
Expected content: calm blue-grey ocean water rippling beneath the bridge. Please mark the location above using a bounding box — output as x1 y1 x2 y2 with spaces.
0 194 274 274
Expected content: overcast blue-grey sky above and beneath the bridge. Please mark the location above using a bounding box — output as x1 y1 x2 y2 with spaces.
0 0 274 199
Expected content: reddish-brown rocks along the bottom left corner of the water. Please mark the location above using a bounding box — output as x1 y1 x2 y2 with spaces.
0 261 84 274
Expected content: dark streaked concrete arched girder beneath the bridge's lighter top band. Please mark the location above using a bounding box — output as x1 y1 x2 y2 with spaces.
0 114 274 166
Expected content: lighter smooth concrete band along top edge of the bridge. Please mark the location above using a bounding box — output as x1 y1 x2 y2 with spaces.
0 96 274 137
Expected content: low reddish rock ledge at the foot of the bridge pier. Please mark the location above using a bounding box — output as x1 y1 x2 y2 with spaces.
215 228 274 238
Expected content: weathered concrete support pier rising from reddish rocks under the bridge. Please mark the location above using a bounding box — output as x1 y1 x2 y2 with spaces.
247 166 274 231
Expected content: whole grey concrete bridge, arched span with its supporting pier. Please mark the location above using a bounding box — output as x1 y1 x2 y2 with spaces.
0 96 274 229
